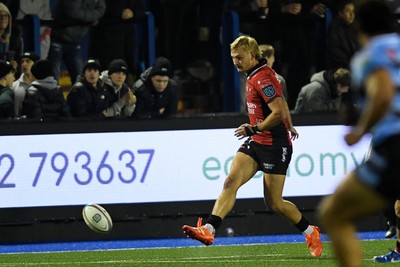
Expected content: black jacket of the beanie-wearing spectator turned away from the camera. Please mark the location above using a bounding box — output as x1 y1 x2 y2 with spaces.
22 76 70 120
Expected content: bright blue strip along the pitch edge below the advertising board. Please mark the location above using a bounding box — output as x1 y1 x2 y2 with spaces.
0 231 392 254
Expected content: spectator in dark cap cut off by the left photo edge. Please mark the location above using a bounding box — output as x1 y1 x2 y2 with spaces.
0 60 15 119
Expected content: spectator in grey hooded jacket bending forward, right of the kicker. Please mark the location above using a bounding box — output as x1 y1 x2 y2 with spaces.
294 68 351 113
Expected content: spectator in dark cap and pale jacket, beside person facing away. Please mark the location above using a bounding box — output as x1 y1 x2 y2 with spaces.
12 52 39 117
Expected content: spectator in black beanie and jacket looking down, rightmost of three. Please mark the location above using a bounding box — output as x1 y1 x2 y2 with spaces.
133 57 178 118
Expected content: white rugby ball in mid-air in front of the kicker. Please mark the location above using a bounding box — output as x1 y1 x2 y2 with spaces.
82 204 113 233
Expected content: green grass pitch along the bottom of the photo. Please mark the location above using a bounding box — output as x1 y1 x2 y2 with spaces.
0 239 395 267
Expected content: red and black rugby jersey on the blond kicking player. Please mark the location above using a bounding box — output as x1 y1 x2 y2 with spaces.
246 61 292 146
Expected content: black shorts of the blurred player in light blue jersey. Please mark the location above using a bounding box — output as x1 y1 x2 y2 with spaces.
356 135 400 200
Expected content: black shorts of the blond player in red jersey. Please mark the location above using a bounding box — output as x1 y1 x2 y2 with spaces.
238 140 293 175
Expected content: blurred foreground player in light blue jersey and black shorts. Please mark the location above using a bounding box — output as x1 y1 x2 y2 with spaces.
319 0 400 266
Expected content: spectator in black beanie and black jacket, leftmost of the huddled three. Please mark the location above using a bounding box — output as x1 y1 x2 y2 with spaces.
67 59 110 119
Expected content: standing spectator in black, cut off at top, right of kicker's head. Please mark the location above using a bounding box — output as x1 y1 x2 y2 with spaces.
278 0 326 109
